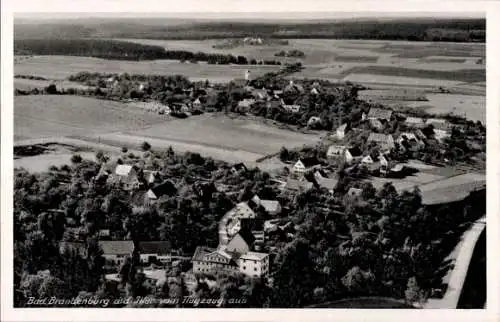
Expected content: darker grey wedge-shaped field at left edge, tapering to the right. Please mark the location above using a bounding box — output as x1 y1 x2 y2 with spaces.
14 95 168 139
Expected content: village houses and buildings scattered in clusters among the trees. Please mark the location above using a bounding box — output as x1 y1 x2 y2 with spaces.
47 66 485 300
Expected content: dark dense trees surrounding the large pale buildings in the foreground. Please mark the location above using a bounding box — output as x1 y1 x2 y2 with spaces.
14 146 485 307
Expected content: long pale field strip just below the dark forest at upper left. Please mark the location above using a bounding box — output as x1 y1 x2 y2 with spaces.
14 56 280 82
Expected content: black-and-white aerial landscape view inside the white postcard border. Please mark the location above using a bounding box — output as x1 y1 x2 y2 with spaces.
13 12 486 309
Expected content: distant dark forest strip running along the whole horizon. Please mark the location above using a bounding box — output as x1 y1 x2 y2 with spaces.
14 18 486 42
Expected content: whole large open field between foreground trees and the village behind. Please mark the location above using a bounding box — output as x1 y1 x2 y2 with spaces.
14 95 319 164
